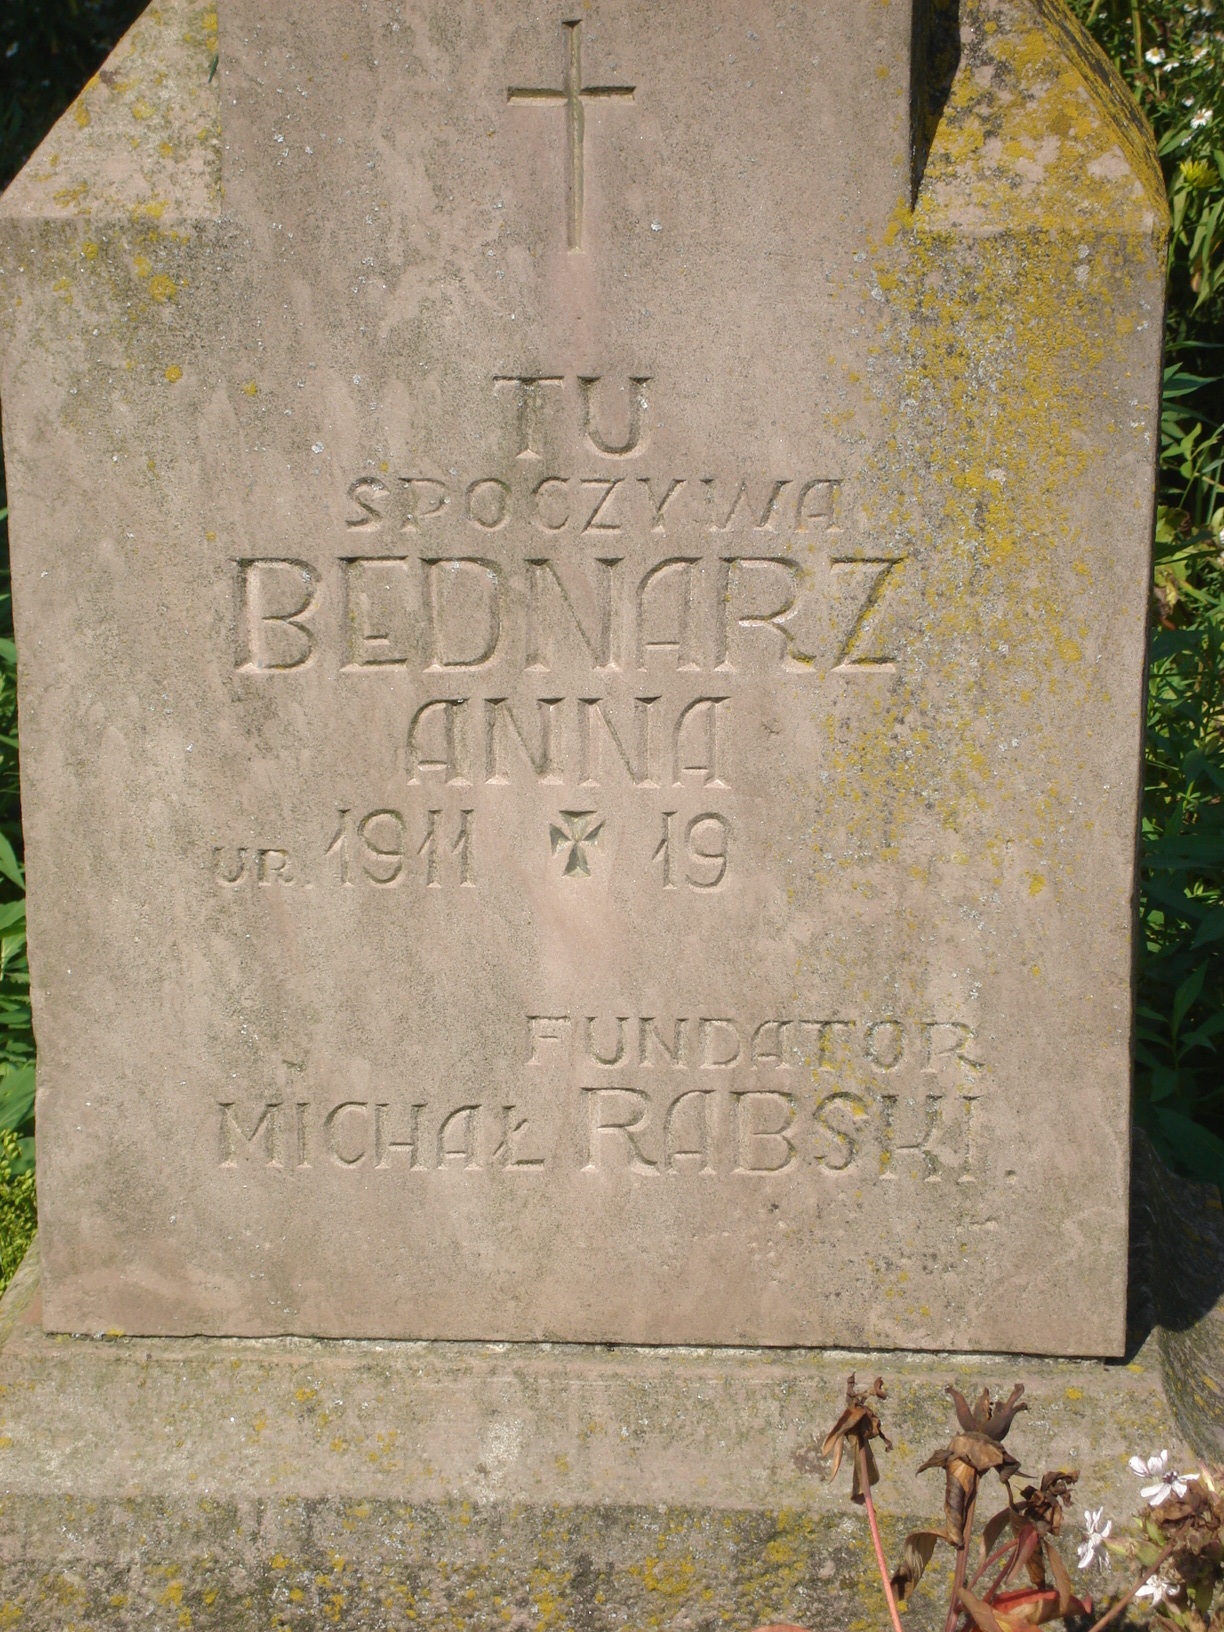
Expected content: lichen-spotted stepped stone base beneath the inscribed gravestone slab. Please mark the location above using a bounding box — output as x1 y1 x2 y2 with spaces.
0 1233 1191 1632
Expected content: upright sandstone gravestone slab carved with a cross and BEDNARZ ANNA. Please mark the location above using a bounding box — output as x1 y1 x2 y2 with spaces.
0 0 1164 1353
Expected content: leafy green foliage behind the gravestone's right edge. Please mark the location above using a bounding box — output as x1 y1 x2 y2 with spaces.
1069 0 1224 1188
